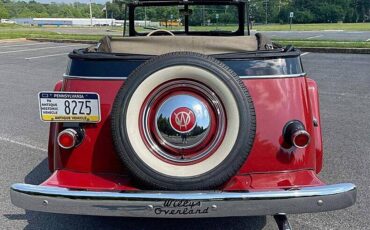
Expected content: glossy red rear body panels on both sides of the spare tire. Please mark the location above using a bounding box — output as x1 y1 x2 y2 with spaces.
44 77 322 190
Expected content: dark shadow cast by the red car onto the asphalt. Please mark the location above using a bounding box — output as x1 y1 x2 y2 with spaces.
4 159 266 230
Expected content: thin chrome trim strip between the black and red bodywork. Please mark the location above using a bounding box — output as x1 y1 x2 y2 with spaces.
63 73 306 80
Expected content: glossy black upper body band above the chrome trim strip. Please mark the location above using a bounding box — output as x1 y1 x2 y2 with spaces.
66 50 303 78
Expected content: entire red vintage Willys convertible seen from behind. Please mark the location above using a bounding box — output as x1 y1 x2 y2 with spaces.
11 0 356 228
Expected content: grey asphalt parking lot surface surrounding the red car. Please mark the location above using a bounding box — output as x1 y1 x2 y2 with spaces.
0 41 370 230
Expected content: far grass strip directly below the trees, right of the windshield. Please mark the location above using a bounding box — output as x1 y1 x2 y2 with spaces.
253 23 370 31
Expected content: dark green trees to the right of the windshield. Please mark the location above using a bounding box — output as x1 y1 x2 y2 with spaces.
250 0 370 23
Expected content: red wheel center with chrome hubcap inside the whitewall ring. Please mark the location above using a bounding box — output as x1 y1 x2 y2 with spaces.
140 80 226 164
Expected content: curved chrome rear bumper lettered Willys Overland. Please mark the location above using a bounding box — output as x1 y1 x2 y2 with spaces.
10 183 356 218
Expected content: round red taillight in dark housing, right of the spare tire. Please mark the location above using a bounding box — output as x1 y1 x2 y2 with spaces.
283 120 311 148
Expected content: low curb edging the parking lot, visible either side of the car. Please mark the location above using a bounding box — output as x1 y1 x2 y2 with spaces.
27 38 370 54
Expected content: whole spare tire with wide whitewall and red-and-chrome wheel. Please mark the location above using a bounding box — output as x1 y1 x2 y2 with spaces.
111 52 256 190
